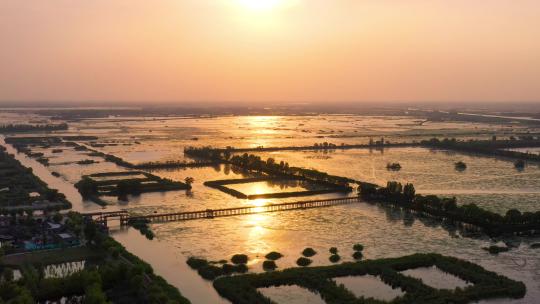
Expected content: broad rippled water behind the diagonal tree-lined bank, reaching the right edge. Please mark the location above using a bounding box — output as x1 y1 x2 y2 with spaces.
258 148 540 213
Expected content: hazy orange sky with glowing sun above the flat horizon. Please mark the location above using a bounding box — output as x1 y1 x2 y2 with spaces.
0 0 540 102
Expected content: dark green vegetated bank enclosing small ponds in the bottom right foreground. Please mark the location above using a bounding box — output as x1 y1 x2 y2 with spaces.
213 253 526 304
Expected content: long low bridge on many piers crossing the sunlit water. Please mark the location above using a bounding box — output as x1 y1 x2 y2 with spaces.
83 196 361 226
